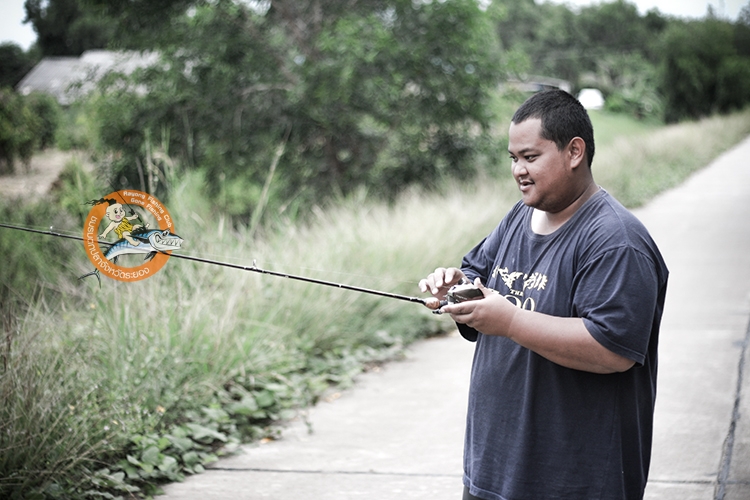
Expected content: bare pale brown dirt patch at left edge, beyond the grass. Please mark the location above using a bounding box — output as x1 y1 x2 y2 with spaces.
0 148 93 199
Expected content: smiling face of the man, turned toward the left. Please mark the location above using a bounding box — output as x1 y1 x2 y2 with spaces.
508 118 575 213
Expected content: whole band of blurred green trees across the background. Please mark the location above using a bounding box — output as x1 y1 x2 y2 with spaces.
0 0 750 213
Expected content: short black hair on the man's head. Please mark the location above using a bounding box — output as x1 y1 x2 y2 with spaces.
511 90 594 167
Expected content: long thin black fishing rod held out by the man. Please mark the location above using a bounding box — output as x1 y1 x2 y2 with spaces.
0 223 444 311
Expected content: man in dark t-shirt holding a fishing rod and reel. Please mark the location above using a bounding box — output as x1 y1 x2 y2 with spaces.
419 90 668 500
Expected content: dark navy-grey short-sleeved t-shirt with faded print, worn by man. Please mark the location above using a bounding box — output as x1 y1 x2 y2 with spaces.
459 190 668 500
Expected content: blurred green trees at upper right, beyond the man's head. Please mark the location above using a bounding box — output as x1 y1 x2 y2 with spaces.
494 0 750 121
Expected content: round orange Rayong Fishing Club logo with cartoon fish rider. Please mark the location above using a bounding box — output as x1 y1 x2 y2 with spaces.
83 189 182 281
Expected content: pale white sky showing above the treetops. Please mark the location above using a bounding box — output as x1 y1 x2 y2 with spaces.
0 0 750 50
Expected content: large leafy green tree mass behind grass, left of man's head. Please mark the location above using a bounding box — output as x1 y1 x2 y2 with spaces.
92 0 501 220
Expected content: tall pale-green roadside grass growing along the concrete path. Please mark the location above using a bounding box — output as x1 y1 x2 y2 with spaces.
0 104 750 498
